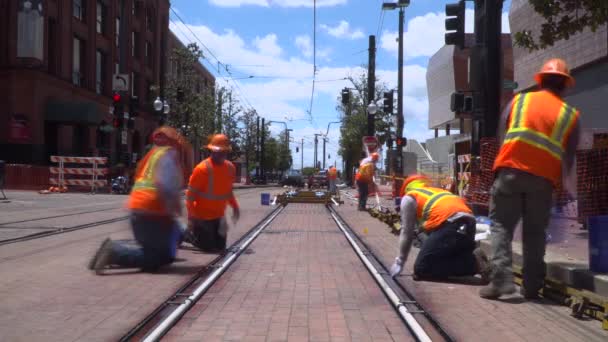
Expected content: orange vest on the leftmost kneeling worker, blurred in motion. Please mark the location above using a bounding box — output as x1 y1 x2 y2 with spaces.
127 146 171 215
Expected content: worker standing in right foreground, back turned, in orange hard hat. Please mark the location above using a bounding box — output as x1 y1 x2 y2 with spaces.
479 59 579 299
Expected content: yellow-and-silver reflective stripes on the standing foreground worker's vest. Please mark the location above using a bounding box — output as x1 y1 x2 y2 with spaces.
504 94 576 161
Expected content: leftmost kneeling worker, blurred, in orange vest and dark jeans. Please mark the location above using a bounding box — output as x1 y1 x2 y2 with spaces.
89 127 192 274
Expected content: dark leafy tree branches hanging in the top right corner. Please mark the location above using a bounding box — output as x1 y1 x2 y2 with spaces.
514 0 608 51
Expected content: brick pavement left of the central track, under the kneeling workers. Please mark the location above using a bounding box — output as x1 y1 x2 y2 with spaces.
0 190 271 342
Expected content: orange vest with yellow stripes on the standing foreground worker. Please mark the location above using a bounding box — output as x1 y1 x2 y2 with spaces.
493 91 579 186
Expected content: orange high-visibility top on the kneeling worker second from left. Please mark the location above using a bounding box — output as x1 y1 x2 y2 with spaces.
186 158 237 220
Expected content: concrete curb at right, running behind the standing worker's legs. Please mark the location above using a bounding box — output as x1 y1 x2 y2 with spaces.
481 240 608 297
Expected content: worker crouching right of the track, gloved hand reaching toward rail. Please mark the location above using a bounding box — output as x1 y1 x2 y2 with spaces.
390 175 490 282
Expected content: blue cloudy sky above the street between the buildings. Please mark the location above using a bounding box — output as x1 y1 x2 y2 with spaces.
170 0 510 168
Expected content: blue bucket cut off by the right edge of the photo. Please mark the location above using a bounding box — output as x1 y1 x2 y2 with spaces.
587 215 608 273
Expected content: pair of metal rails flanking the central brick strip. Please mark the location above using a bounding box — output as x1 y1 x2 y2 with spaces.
120 204 454 342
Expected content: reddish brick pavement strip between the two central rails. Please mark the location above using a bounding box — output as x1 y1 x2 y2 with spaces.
165 204 412 341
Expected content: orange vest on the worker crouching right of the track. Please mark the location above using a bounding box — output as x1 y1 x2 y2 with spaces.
406 187 473 232
